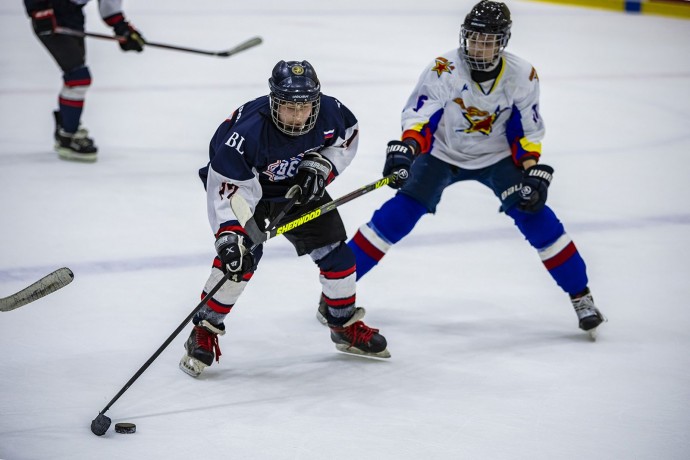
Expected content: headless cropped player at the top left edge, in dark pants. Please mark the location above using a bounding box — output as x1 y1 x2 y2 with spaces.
24 0 144 162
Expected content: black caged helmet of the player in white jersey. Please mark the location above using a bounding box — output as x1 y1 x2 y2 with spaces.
460 0 513 70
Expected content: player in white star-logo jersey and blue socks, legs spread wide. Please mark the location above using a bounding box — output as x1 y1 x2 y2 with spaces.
348 0 605 336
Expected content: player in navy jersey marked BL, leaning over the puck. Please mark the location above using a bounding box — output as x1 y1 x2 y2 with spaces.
180 61 390 376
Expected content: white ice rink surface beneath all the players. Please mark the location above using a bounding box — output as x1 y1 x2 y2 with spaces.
0 0 690 460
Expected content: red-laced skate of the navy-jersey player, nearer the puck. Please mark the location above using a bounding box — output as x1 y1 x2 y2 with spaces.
180 320 225 377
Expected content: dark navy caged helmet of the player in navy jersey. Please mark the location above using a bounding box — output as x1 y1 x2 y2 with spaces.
268 61 321 136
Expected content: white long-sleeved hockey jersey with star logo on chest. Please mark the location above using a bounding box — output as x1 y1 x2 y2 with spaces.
402 49 544 169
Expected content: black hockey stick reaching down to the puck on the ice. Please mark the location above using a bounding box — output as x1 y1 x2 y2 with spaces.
91 194 299 436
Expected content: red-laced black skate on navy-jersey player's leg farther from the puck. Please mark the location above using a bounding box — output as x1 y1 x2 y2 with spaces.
328 307 391 358
